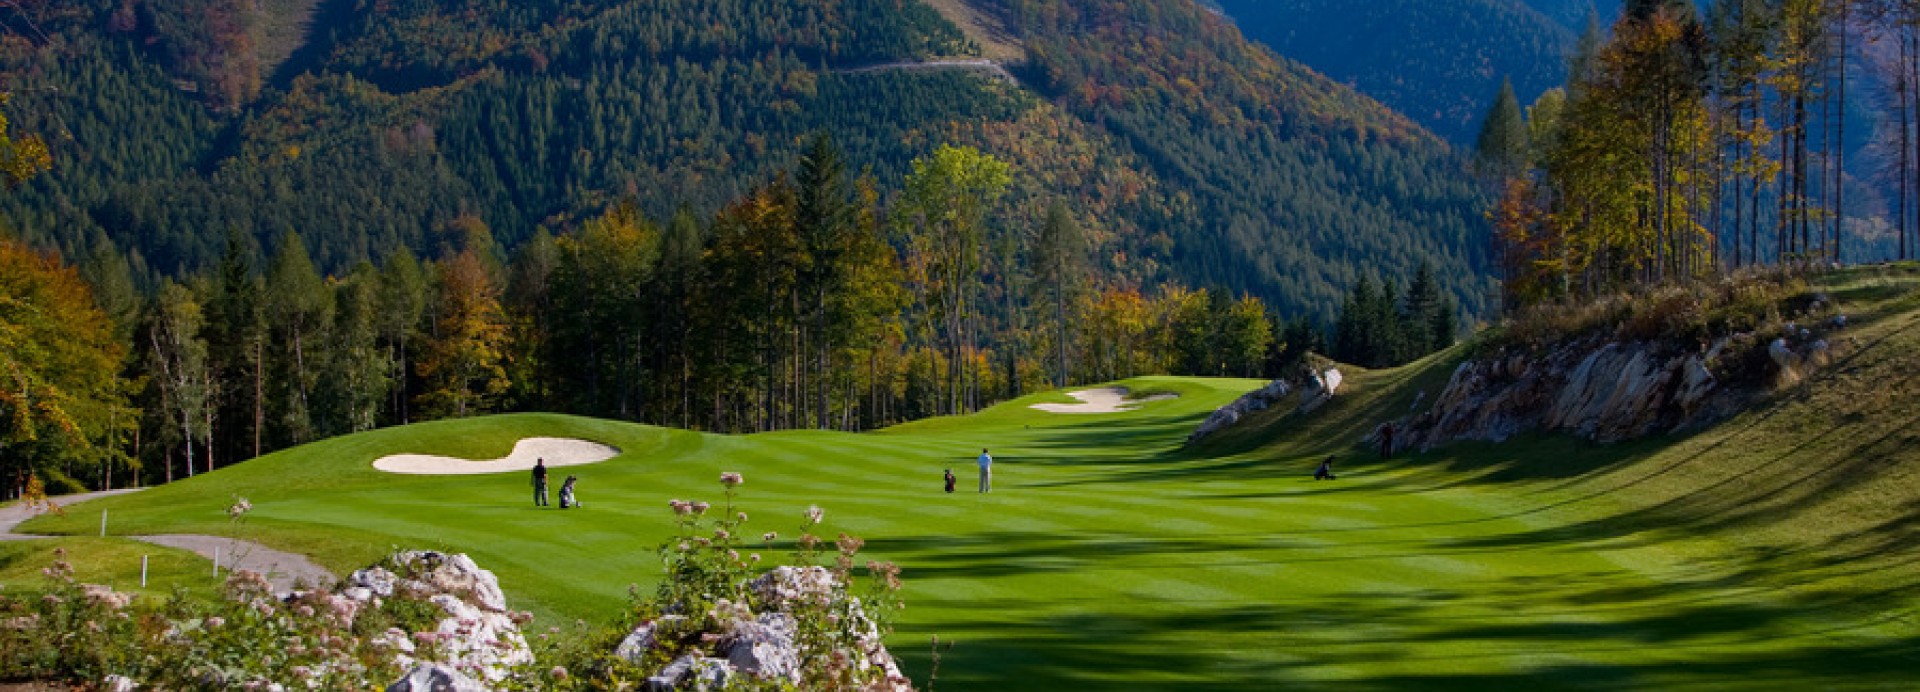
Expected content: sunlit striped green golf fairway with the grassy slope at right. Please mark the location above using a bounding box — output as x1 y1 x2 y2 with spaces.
25 269 1920 690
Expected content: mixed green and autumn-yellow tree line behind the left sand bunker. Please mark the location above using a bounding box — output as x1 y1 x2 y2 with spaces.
0 135 1457 492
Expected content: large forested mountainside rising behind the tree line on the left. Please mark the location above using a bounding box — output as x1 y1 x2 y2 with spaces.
0 0 1488 323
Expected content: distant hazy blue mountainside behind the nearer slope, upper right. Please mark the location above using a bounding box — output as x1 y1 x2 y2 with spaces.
1219 0 1584 146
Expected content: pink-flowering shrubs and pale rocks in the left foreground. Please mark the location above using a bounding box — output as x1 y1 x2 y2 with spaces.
0 473 906 690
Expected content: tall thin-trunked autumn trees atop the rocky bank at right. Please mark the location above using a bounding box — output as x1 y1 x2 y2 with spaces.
1476 0 1920 304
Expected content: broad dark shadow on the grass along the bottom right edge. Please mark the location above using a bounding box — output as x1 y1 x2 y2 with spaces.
895 581 1920 690
